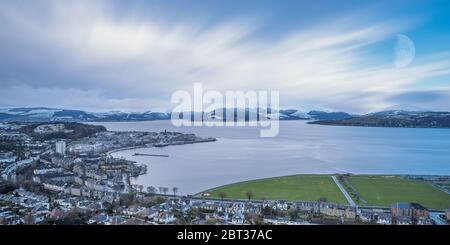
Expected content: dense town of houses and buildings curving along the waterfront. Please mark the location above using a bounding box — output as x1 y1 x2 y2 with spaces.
0 122 450 225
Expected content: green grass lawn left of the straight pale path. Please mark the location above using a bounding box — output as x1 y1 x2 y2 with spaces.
203 175 348 204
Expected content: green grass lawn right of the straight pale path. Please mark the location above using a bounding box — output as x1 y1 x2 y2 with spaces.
349 176 450 209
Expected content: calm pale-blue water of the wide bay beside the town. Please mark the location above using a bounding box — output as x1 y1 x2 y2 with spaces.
90 121 450 194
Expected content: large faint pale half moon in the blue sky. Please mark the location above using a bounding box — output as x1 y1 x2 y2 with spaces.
394 34 416 68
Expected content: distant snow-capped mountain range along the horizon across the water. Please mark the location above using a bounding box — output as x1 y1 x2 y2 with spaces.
0 107 450 128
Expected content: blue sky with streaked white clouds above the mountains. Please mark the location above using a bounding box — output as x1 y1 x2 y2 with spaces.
0 0 450 113
